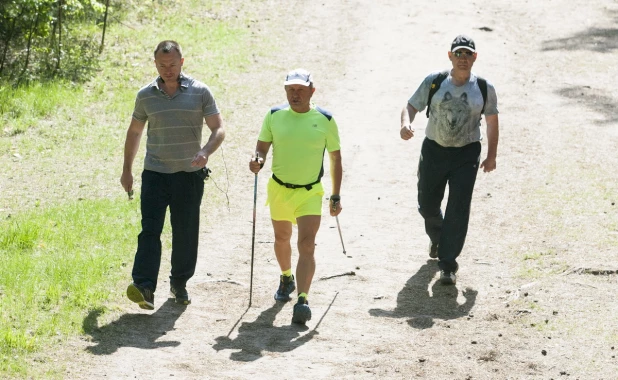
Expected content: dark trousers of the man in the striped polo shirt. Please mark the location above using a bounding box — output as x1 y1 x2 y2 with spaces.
132 170 204 291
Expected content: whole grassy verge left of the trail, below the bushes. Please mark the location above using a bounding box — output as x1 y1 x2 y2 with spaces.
0 0 276 378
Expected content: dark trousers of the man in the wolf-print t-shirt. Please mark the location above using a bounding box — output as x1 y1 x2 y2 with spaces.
418 138 481 272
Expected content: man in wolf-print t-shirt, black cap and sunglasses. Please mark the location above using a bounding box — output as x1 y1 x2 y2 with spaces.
399 35 499 285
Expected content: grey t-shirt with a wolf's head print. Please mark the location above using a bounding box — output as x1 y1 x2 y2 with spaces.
408 72 498 147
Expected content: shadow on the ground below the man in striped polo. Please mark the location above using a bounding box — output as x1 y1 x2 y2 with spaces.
82 298 186 355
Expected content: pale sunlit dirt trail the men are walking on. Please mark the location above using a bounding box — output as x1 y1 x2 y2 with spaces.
67 0 618 379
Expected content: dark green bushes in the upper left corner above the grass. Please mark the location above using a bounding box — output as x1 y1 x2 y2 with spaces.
0 0 114 83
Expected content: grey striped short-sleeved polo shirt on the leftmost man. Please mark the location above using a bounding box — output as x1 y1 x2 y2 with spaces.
133 74 219 173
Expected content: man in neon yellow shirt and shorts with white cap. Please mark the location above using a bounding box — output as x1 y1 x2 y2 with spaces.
249 69 343 324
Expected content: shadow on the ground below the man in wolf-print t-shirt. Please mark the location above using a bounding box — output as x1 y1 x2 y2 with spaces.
369 260 478 329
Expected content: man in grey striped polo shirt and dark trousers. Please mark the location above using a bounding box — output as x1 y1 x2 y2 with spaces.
120 41 225 310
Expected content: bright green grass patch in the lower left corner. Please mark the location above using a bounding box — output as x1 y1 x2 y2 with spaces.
0 199 153 373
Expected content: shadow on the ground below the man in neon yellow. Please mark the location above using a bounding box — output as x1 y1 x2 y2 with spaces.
212 302 318 362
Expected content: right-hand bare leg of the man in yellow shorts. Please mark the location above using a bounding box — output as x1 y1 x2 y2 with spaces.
296 215 322 294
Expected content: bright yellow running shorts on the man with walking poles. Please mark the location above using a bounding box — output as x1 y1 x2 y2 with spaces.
266 177 324 224
